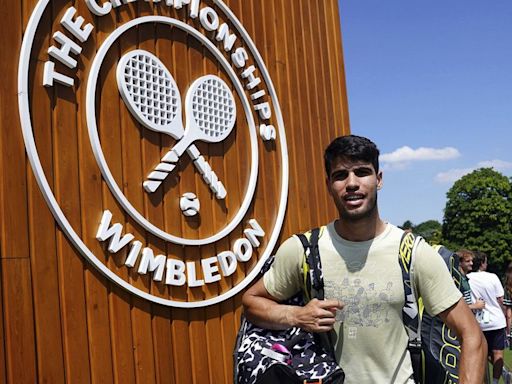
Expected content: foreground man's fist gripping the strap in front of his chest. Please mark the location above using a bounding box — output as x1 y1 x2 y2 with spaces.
292 299 345 332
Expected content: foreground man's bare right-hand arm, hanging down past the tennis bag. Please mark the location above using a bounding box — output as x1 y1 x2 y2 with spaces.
439 299 487 384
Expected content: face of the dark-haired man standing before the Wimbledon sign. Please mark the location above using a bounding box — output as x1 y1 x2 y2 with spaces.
326 158 382 221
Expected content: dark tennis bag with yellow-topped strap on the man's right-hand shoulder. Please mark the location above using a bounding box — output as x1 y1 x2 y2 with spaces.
399 233 461 384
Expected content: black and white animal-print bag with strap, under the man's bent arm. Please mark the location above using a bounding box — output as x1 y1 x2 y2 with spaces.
233 228 345 384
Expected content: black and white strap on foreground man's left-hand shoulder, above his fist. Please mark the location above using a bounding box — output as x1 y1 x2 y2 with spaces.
297 228 324 300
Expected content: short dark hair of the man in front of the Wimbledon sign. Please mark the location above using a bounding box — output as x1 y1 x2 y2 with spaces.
324 135 379 177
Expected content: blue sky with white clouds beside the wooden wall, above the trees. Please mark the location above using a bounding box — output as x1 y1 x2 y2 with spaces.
340 0 512 225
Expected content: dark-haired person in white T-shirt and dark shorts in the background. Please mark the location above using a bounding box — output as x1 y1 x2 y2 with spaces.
468 252 507 384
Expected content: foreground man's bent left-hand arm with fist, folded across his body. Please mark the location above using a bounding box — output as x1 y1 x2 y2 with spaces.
242 278 343 332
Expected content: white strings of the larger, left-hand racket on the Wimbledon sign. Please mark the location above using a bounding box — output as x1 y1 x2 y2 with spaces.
124 54 180 126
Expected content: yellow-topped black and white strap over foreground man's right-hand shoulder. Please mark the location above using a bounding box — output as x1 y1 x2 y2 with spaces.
398 232 422 344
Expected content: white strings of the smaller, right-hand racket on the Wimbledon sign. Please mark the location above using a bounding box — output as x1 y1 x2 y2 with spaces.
192 79 235 138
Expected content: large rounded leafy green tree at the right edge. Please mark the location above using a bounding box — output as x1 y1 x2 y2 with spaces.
442 168 512 270
